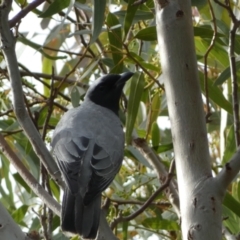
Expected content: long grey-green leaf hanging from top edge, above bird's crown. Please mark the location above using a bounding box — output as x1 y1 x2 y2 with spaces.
90 0 106 44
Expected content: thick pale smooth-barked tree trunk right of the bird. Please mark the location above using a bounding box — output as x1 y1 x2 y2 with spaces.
155 0 225 240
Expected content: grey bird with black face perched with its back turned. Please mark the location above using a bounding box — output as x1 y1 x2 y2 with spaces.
51 72 133 239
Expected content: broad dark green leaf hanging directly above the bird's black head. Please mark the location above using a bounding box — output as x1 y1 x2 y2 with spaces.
107 13 123 73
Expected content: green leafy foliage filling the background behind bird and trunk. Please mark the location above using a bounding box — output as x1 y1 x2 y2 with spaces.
0 0 240 239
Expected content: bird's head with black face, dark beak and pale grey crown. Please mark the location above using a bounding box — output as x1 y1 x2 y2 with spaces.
85 72 133 115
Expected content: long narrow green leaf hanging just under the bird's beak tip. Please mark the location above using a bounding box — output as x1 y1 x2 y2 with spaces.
126 73 145 144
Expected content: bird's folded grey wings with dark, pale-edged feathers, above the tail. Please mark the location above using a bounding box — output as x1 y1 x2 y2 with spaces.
54 133 122 201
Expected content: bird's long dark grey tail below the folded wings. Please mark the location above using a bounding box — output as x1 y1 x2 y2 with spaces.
62 190 101 239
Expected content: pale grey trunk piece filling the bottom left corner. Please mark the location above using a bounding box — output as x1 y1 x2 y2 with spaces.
0 203 29 240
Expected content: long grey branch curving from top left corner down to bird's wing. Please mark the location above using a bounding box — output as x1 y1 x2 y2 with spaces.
0 0 64 186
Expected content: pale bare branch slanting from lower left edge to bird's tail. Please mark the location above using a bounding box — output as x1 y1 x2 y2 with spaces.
0 134 61 216
